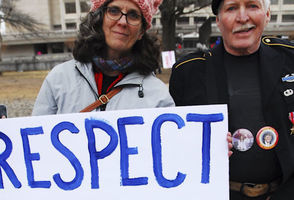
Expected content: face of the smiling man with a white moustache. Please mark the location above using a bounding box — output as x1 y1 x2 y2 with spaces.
216 0 270 56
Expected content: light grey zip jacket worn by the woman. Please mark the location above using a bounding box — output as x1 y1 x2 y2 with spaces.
32 60 174 115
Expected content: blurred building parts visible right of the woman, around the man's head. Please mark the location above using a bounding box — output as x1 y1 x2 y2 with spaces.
153 0 294 49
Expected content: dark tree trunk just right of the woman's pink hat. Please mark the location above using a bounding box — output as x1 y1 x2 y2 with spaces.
160 0 176 51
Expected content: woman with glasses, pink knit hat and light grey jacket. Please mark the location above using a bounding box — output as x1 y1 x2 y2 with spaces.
33 0 174 115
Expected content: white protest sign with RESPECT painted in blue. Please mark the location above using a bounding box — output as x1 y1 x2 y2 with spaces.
0 105 229 200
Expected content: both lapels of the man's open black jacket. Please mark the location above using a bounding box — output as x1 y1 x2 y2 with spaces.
206 40 284 106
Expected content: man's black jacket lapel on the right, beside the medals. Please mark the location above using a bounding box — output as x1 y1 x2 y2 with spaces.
259 43 284 108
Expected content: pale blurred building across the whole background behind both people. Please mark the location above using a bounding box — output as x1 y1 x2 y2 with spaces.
0 0 294 70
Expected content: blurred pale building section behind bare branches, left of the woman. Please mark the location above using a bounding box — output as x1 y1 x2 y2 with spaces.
2 0 89 58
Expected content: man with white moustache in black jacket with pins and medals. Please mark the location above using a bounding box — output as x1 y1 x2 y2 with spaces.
170 0 294 200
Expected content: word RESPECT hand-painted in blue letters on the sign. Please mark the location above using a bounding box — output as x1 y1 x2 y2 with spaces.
0 113 224 190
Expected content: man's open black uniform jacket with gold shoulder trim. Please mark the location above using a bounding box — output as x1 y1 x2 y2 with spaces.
169 37 294 200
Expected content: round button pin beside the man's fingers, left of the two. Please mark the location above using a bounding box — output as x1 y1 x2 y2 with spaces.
232 128 254 151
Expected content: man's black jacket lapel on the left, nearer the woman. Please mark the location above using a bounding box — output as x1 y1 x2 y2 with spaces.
206 43 228 104
